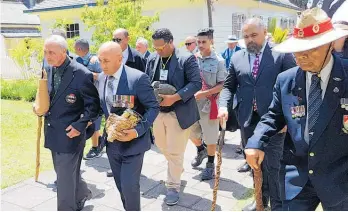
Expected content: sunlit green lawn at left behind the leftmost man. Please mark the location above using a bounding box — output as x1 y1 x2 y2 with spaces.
1 100 91 189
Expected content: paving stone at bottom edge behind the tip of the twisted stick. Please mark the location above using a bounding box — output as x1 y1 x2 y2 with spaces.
192 194 236 211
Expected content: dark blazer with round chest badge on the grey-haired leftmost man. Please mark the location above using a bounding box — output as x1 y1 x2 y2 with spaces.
44 57 100 153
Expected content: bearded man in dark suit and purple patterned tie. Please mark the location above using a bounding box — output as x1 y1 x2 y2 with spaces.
218 18 296 211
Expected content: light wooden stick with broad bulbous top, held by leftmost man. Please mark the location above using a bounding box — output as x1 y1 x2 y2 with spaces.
33 69 50 182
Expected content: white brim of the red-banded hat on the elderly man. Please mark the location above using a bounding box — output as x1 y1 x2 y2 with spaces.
273 29 348 53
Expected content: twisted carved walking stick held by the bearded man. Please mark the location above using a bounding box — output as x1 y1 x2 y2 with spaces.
211 118 226 211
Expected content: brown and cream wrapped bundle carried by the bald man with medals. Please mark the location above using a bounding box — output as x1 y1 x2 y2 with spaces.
105 109 142 142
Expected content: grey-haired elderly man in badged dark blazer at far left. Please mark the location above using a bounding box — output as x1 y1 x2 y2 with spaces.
35 35 101 211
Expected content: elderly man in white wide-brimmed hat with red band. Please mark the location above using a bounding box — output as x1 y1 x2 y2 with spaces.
245 8 348 211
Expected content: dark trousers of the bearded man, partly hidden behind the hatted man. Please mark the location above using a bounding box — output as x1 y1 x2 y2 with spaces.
240 112 285 210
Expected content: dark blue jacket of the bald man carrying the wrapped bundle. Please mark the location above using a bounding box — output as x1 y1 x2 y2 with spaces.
97 66 159 156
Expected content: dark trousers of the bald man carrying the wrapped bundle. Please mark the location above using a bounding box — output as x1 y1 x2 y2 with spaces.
106 146 144 211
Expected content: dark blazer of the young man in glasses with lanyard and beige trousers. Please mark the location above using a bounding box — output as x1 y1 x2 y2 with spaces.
145 49 202 129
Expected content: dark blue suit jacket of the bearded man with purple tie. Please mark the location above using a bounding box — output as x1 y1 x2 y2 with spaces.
219 44 296 127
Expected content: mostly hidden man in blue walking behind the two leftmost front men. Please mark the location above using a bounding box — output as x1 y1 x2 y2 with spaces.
74 39 103 160
